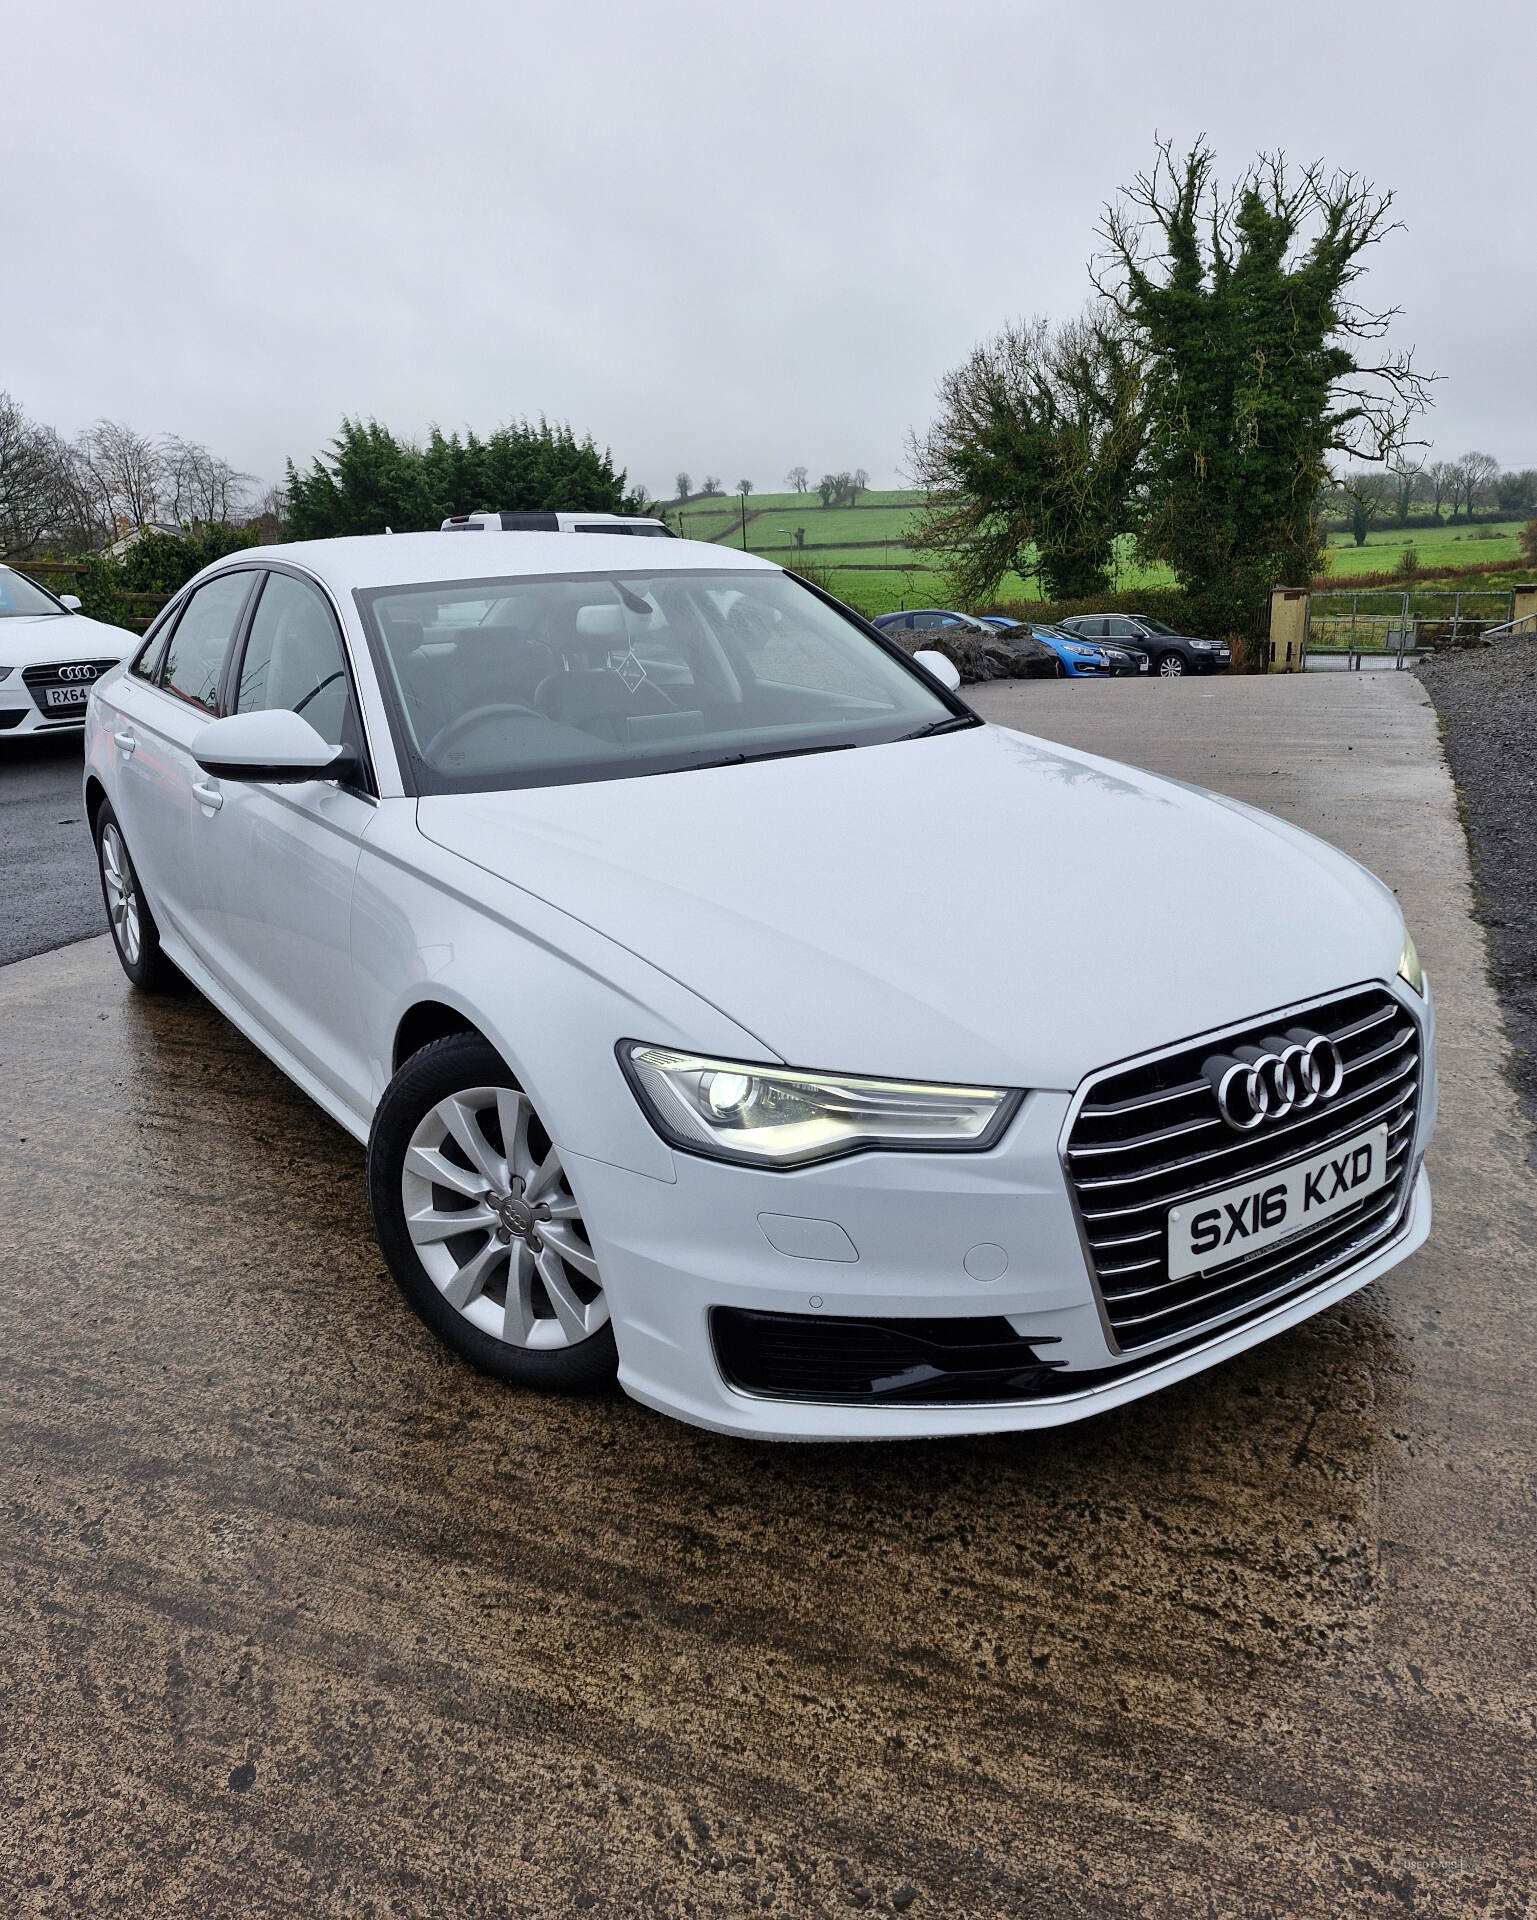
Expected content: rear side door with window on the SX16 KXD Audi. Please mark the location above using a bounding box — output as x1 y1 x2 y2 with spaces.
111 568 257 958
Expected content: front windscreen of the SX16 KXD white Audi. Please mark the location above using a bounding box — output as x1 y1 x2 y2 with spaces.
357 570 959 793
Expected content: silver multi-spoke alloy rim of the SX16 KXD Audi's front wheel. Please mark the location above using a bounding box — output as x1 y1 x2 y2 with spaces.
401 1087 608 1352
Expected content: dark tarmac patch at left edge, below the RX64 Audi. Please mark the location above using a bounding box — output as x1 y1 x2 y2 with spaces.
0 733 106 966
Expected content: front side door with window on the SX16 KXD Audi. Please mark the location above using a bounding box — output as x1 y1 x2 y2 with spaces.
196 568 374 1108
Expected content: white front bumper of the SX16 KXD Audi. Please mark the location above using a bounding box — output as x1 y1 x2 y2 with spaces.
562 1010 1435 1440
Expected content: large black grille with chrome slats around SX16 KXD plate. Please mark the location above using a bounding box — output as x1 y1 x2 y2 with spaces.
1065 987 1422 1354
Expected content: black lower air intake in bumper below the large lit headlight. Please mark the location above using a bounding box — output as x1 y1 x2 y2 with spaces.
710 1308 1061 1405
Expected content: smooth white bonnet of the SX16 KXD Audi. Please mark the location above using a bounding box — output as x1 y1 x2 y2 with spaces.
418 728 1403 1089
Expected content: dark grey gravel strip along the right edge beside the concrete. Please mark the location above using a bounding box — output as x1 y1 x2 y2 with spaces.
1420 639 1537 1144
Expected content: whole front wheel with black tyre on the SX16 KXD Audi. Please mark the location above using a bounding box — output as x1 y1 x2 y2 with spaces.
368 1033 618 1392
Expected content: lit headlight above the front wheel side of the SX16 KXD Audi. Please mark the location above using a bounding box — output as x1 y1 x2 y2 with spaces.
620 1041 1021 1167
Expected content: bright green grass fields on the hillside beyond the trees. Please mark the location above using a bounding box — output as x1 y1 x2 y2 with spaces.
668 492 1522 614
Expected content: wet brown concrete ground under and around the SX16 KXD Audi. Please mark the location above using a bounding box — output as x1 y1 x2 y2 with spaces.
0 676 1537 1920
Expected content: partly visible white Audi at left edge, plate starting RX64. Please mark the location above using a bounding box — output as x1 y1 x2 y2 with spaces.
0 566 138 739
